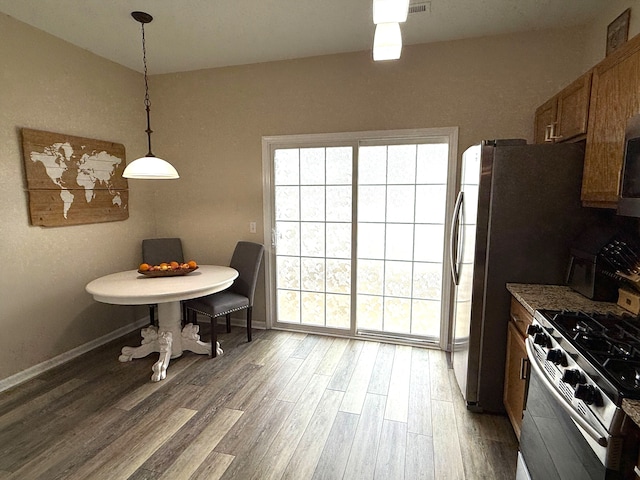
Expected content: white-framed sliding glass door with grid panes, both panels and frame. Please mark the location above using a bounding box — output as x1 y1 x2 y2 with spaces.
263 129 457 343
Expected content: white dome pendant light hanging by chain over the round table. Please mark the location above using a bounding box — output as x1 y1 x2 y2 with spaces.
122 12 180 180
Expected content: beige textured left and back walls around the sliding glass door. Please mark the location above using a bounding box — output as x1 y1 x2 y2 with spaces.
0 4 632 380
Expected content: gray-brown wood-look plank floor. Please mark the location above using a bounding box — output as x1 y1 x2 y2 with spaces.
0 325 517 480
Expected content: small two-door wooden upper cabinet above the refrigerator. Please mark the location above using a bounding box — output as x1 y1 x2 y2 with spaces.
534 71 591 143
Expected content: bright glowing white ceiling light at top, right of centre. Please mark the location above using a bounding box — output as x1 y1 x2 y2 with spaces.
373 0 409 62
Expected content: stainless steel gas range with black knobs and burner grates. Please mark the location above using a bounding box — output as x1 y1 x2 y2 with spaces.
518 310 640 480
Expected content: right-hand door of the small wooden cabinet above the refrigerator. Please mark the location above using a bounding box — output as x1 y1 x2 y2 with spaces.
554 72 592 142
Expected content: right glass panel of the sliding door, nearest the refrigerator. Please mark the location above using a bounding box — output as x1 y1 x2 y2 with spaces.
356 143 449 340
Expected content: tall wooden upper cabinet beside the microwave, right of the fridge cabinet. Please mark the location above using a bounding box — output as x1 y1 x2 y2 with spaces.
582 35 640 208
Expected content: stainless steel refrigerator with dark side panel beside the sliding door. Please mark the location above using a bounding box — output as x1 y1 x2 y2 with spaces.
450 140 596 412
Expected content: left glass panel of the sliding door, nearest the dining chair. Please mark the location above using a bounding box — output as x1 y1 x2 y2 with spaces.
274 147 353 330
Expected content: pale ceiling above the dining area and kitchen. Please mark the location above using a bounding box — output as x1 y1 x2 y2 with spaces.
0 0 607 74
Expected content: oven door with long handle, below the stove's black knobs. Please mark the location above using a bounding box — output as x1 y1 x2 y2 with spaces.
520 339 618 480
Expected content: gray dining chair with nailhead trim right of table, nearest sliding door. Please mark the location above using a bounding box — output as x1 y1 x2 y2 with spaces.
184 241 264 357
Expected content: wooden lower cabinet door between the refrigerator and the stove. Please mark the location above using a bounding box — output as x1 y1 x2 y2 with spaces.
503 322 528 440
